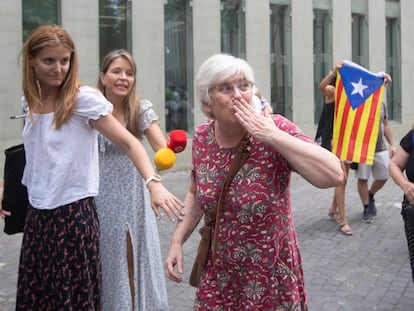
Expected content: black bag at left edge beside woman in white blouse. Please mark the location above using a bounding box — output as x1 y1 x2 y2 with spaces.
2 144 29 234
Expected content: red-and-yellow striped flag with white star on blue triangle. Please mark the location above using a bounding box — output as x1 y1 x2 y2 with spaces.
332 61 385 164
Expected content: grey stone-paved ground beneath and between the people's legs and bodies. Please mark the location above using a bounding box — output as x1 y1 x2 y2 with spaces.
0 171 414 311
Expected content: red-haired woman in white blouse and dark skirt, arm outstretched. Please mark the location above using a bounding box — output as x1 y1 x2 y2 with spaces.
0 25 183 310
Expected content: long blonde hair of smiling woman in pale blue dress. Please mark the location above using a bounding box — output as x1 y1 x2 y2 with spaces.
98 49 143 138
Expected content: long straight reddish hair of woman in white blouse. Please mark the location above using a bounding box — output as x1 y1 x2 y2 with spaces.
22 24 80 129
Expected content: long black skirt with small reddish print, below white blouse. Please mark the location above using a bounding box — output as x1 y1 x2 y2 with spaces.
16 198 101 311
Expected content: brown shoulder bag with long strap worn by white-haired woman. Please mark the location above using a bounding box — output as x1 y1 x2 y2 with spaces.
189 135 250 287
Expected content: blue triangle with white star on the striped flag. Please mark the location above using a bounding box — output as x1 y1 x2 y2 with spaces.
339 61 384 109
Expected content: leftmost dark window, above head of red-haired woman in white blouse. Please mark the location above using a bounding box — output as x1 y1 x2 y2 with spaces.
22 0 61 42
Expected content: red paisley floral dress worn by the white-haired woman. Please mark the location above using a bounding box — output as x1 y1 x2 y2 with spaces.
192 115 313 311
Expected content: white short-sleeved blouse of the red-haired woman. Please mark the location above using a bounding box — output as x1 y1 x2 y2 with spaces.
22 86 113 209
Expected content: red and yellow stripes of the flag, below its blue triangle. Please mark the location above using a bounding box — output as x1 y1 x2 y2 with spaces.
332 74 384 164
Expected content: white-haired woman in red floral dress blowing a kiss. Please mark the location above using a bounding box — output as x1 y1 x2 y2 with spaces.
165 54 343 310
